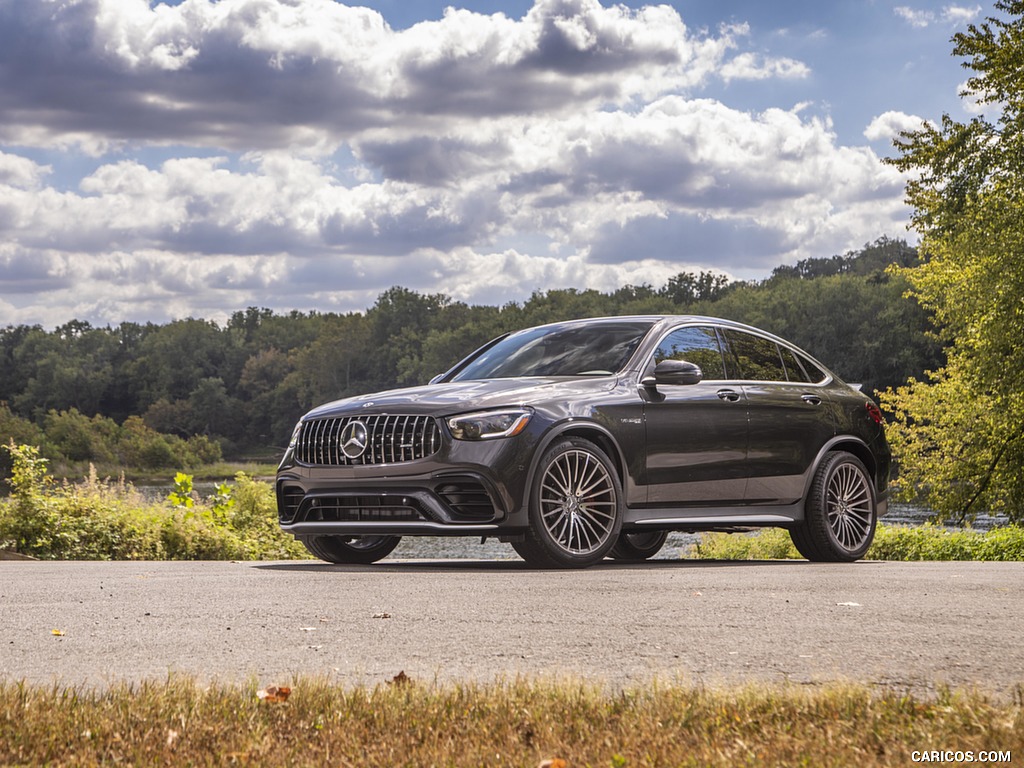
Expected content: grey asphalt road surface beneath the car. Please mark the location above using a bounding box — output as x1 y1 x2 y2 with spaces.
0 560 1024 695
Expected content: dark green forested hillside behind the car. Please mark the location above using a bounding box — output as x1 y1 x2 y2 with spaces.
0 238 942 475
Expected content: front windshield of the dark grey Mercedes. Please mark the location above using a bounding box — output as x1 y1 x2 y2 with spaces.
452 321 653 381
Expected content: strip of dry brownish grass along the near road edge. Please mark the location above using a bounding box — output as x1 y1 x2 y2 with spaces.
0 676 1024 768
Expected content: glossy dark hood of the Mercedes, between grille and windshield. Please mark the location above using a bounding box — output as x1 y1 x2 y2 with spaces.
303 376 617 419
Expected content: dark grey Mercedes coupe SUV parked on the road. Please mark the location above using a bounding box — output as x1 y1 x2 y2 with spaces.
276 316 890 567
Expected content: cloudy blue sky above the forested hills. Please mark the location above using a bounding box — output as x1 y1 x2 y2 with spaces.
0 0 993 328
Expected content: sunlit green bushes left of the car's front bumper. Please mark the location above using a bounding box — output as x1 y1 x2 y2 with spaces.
0 443 307 560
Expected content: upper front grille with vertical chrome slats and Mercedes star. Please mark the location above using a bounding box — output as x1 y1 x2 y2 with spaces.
295 415 441 467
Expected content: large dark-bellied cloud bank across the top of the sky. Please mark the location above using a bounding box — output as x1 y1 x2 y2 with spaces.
0 0 770 152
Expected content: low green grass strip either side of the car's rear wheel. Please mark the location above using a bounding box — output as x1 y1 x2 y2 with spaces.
690 524 1024 561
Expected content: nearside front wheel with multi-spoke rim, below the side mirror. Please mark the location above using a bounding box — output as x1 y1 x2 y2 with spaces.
512 437 623 568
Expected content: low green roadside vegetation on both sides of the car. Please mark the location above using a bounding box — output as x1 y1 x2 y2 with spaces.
0 443 1024 560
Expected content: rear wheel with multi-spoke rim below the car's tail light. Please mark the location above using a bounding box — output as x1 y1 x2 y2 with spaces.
790 451 879 562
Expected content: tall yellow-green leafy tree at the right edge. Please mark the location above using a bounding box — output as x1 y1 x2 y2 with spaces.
883 0 1024 520
